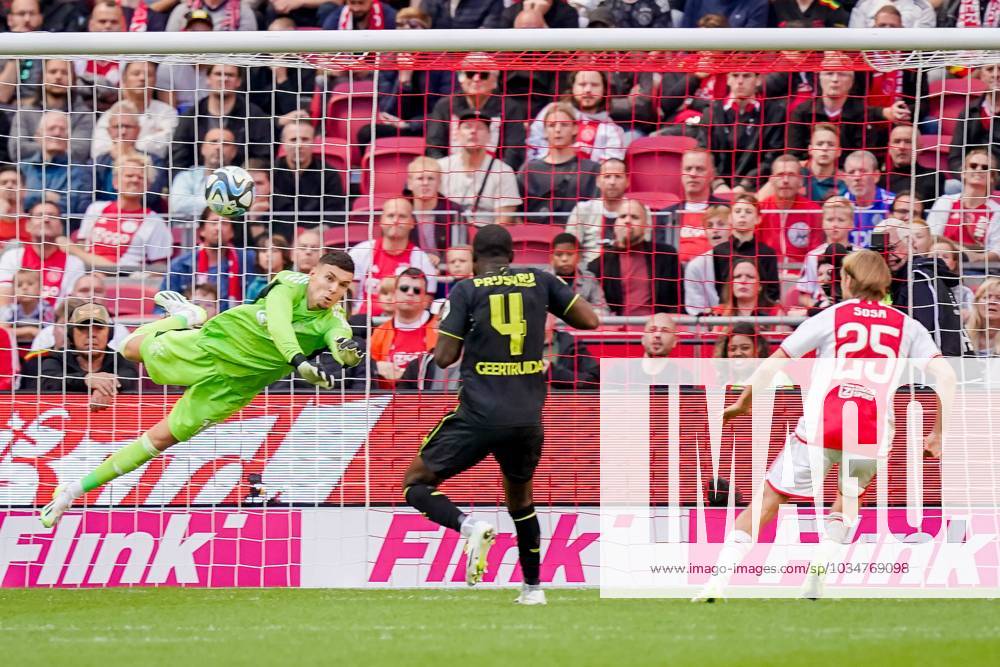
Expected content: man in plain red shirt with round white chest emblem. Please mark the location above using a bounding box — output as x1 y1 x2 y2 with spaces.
759 153 823 262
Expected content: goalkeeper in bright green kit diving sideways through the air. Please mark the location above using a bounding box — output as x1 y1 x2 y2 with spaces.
40 251 365 528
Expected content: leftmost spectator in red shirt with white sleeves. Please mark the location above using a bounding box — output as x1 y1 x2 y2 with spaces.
0 200 87 306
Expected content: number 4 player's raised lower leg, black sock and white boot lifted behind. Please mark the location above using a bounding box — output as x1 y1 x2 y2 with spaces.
403 454 496 586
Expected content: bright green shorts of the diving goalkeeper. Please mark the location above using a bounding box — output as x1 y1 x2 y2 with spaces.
141 329 262 442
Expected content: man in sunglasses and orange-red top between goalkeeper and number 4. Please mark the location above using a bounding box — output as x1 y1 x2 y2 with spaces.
371 266 438 389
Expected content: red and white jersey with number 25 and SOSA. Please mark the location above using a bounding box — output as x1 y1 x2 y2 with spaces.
781 299 941 458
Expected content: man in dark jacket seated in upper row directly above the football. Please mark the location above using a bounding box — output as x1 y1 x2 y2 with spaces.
172 64 274 169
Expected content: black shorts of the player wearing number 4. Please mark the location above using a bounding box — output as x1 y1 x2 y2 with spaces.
420 412 545 482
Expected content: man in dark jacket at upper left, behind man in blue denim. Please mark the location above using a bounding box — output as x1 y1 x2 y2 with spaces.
7 58 94 167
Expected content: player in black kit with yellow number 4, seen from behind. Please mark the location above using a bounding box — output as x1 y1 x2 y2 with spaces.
403 225 599 604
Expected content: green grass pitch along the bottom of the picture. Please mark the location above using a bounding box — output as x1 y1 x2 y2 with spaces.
0 588 1000 667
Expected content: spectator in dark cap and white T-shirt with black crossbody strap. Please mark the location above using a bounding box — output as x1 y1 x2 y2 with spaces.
438 109 521 224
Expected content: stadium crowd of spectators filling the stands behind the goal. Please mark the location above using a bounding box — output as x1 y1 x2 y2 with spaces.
0 0 1000 400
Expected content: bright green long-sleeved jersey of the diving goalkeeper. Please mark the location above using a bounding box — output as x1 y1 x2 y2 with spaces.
199 271 353 381
